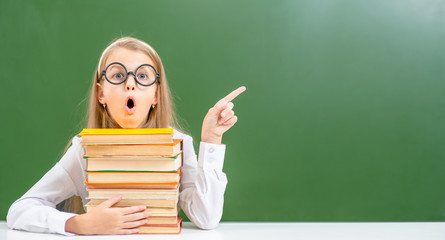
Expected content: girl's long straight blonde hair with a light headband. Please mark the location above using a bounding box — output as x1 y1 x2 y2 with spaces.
62 37 182 213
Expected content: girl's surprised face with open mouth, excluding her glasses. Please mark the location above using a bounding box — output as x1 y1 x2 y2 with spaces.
97 48 158 128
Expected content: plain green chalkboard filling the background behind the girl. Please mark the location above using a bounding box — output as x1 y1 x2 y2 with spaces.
0 0 445 221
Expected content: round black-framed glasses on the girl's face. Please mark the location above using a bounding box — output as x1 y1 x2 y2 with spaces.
97 62 161 87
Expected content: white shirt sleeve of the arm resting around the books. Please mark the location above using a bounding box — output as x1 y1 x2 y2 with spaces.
7 136 85 235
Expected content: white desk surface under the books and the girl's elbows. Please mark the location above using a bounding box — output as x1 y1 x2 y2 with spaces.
0 221 445 240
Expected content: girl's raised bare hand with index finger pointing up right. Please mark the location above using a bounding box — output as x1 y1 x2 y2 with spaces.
201 87 246 144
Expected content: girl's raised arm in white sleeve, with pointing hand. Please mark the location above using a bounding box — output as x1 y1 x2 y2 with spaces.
179 87 246 229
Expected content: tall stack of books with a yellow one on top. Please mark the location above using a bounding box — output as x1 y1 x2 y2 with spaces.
79 128 183 234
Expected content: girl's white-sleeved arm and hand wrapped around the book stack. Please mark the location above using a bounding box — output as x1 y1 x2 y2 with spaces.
7 138 150 235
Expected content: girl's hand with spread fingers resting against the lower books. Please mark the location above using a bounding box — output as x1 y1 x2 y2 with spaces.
65 195 151 235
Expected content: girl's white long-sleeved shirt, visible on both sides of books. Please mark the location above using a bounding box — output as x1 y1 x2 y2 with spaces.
6 130 227 235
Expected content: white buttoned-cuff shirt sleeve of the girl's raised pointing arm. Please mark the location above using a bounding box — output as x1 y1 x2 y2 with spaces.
179 137 227 229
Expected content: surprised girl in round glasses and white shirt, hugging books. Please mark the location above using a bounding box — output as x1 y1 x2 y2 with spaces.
7 37 246 235
